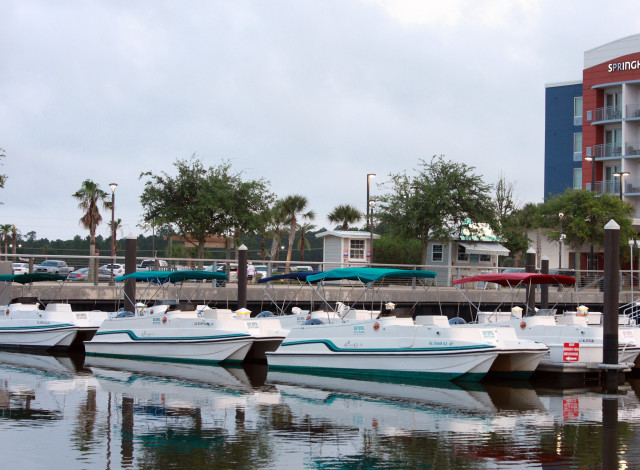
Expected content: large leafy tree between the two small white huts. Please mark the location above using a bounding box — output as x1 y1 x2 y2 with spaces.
376 156 495 265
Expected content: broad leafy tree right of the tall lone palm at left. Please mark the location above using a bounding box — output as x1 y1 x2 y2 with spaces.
140 156 273 258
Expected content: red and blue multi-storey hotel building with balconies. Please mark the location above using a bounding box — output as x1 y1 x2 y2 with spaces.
544 34 640 267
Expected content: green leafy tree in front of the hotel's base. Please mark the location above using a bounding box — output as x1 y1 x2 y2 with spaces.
541 189 636 269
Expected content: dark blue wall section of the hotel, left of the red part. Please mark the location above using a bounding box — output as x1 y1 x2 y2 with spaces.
543 83 582 199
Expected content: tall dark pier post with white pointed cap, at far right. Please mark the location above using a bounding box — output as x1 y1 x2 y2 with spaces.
602 219 620 390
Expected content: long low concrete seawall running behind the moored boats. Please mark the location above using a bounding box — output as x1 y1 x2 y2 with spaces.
12 283 616 311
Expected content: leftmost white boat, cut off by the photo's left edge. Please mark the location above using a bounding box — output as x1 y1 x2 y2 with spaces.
0 273 78 350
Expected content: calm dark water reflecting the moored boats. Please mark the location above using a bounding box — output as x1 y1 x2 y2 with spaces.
0 352 640 469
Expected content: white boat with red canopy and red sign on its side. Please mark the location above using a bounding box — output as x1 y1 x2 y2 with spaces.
454 272 640 374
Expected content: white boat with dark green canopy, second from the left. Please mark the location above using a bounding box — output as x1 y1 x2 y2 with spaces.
84 271 255 363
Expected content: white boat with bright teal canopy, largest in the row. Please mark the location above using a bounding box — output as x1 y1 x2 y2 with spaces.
267 268 498 380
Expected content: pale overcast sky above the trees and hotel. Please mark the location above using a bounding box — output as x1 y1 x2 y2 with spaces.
0 0 640 239
